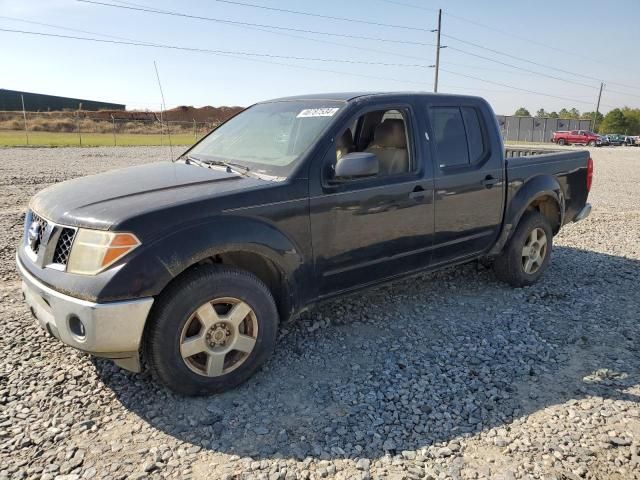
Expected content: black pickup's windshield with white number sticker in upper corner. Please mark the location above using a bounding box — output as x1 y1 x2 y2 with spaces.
189 100 345 177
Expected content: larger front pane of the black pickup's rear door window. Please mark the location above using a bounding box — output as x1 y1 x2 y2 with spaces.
429 107 469 167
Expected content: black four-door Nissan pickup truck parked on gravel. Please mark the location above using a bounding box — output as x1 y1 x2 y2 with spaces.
17 93 593 395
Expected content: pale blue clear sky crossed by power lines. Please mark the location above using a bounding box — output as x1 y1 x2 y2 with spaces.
0 0 640 114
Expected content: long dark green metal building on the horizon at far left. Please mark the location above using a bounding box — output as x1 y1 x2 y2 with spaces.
0 89 126 112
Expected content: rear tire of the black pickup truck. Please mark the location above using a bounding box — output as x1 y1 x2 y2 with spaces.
493 211 553 287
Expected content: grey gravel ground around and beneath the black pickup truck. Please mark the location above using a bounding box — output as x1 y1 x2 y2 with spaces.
0 147 640 480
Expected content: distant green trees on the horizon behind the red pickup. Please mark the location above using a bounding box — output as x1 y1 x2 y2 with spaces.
514 107 640 135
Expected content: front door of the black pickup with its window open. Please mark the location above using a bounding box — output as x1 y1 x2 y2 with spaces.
310 105 433 296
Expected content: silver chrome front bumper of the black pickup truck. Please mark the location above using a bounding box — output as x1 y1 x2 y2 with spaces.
17 253 153 371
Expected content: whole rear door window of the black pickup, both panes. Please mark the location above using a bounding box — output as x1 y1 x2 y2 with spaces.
429 107 487 168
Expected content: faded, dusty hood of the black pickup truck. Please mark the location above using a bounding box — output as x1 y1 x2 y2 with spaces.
29 162 269 230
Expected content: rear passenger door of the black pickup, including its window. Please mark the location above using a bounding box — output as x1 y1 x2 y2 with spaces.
427 100 504 263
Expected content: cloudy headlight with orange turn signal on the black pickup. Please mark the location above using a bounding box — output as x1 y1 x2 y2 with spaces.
67 228 140 275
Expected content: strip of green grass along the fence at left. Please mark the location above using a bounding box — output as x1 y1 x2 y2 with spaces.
0 130 195 147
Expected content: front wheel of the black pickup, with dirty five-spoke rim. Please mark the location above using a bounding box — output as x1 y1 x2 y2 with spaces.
143 265 279 396
